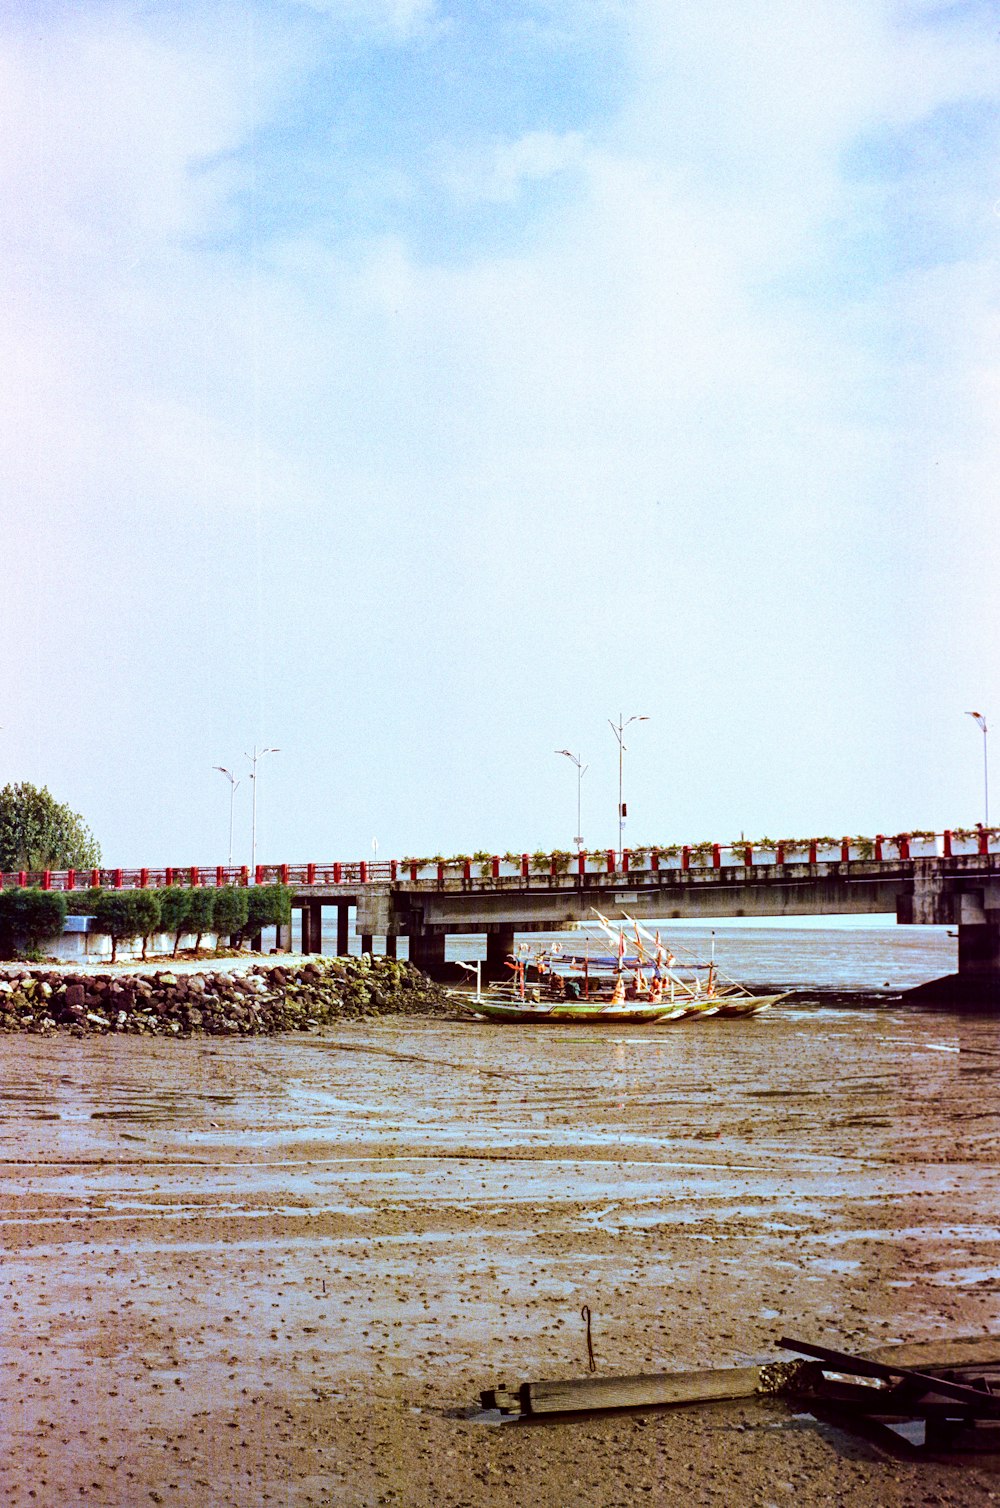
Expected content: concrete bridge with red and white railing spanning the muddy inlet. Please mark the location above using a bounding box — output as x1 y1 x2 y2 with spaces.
13 829 1000 1010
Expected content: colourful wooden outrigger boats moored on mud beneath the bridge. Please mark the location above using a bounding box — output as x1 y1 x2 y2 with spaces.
463 911 784 1025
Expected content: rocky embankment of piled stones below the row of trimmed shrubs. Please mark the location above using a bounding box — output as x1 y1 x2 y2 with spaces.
0 956 451 1036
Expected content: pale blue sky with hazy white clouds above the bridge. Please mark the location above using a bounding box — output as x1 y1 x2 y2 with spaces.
0 0 1000 866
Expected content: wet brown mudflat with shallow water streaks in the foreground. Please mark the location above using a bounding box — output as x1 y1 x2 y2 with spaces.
0 1007 1000 1508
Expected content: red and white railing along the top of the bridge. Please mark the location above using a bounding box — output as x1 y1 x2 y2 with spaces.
0 826 1000 891
